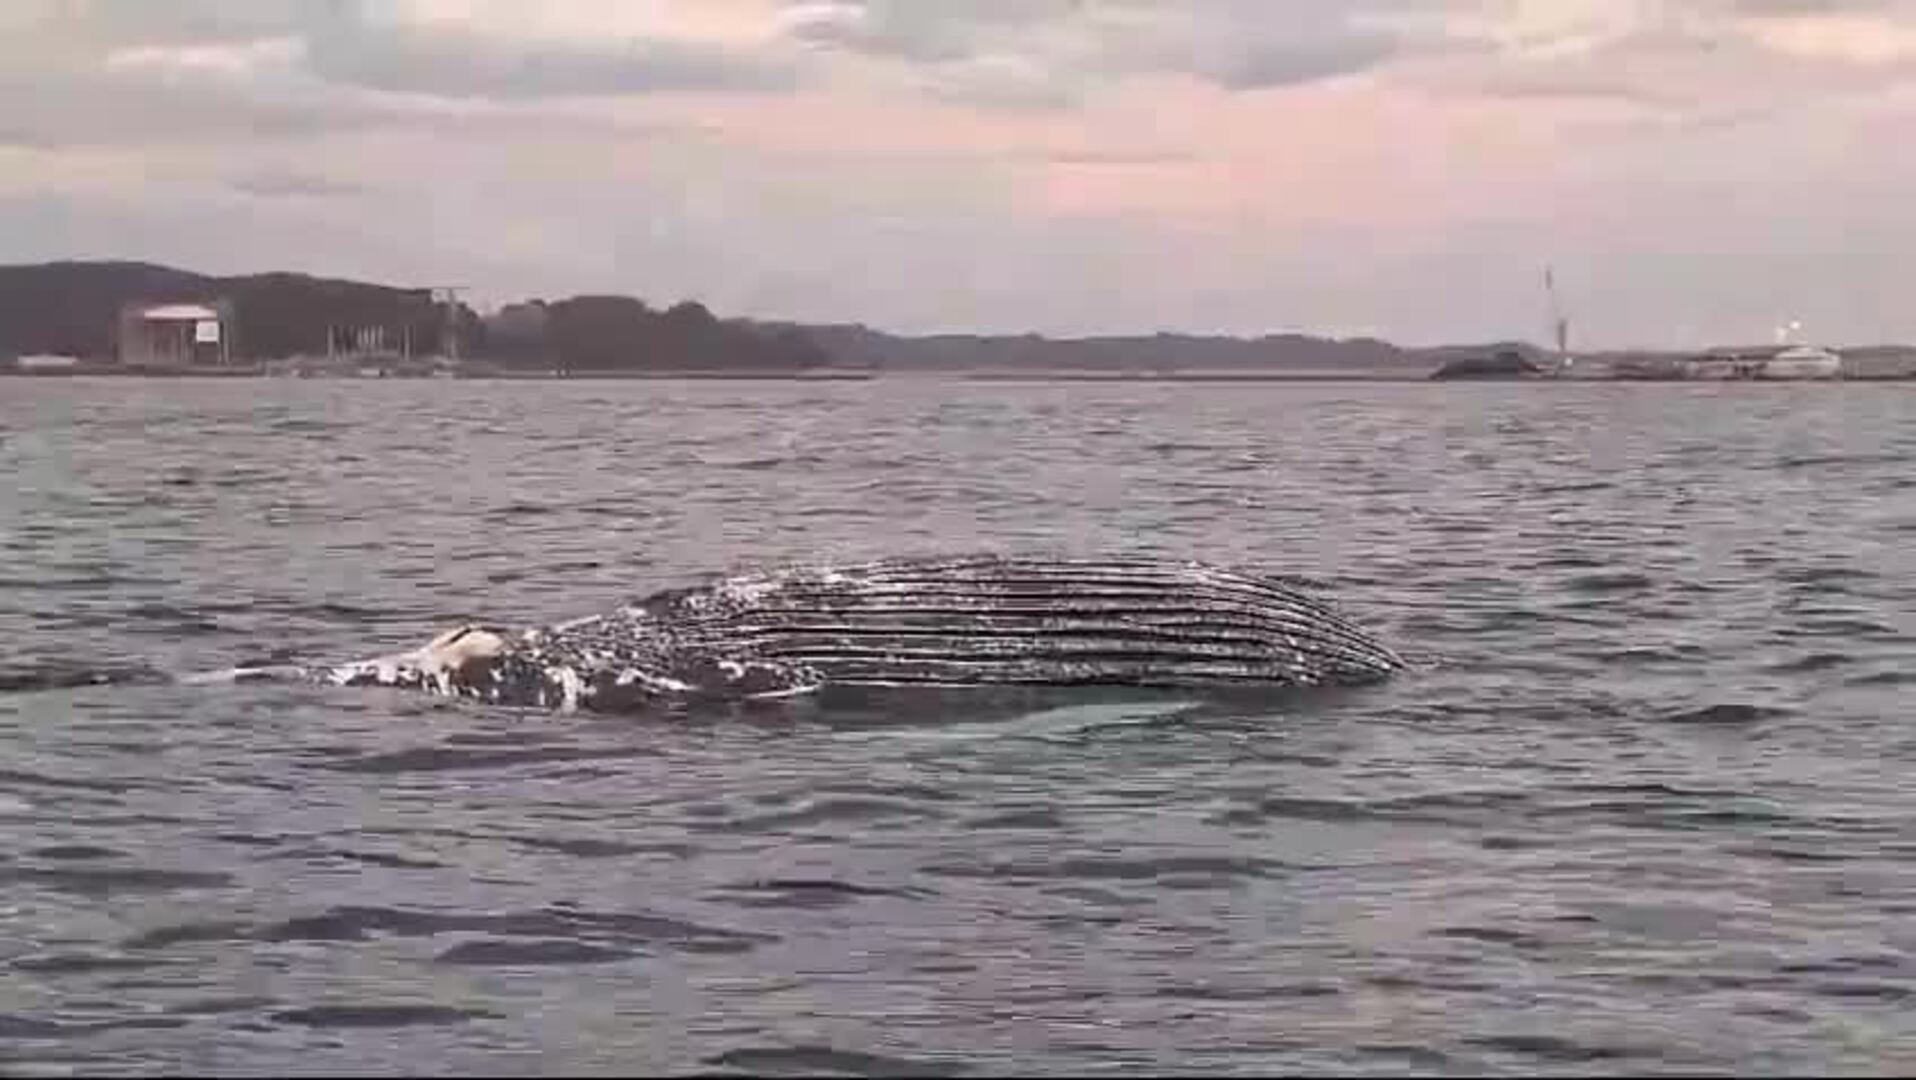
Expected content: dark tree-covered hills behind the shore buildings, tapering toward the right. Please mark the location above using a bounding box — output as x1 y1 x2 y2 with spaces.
0 262 1531 373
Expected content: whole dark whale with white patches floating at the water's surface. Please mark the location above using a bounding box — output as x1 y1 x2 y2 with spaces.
279 553 1404 712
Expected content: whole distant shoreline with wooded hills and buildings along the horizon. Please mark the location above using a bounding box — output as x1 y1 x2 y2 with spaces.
11 260 1916 385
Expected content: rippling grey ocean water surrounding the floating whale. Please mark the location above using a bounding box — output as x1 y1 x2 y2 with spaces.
0 379 1916 1076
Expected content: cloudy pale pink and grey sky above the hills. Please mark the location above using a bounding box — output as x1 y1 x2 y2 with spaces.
0 0 1916 349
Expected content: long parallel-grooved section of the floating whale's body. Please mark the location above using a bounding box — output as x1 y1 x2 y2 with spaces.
634 555 1403 686
